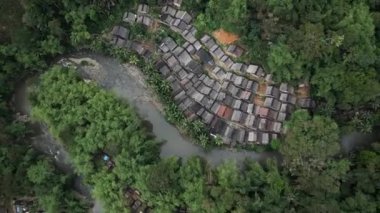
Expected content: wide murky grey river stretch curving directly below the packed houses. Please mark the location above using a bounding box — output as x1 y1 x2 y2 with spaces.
68 53 279 165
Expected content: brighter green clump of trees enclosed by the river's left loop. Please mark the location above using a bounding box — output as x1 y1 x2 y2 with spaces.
33 66 159 212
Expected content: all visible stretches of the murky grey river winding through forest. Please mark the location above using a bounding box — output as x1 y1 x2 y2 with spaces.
14 53 374 213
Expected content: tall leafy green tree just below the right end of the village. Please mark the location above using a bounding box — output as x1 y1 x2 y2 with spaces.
280 110 349 209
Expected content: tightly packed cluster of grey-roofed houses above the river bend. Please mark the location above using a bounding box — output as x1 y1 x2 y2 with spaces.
107 4 313 146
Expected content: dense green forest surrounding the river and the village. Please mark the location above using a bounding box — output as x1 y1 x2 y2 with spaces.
0 0 380 213
